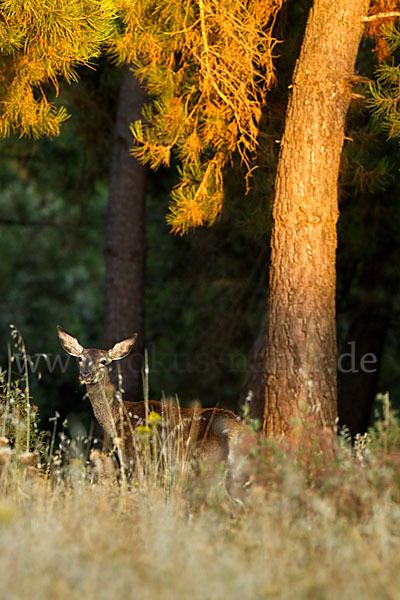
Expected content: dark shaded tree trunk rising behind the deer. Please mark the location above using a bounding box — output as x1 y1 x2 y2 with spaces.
104 65 147 401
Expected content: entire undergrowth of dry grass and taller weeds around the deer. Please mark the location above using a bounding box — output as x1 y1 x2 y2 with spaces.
0 340 400 600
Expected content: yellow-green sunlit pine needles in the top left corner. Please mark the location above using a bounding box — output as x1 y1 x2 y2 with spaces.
0 0 115 138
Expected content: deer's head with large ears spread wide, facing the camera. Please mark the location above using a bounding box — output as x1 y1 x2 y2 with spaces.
57 325 137 384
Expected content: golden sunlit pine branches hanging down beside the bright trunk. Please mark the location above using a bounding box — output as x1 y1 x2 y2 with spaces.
111 0 282 233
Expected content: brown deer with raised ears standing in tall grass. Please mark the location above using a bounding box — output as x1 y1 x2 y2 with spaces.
57 325 242 473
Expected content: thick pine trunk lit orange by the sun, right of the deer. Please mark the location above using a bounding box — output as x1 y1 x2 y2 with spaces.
264 0 369 434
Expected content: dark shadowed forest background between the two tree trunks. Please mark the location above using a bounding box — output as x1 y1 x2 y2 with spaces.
146 166 269 410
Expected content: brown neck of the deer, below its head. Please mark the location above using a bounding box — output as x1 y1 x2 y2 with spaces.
86 369 118 436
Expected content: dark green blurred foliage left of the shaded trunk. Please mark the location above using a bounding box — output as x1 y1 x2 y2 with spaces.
0 116 110 426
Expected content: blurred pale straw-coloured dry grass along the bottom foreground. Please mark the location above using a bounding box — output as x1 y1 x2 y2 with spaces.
0 446 400 600
